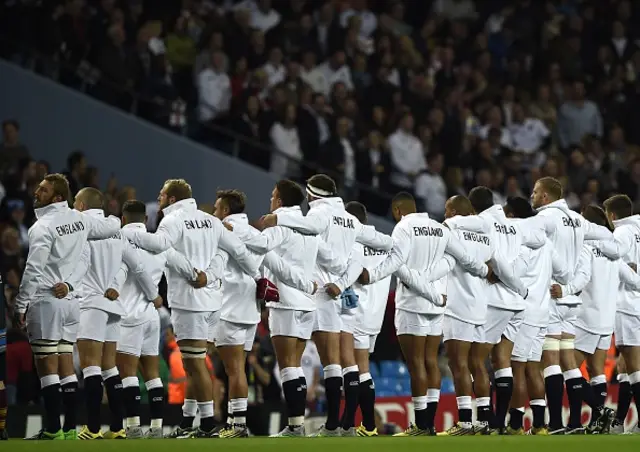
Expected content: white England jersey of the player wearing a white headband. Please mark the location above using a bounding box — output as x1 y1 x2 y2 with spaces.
274 197 393 283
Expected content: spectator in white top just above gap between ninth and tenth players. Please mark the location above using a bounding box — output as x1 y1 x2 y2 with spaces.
415 152 447 221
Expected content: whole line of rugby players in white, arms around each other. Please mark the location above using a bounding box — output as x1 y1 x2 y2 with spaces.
12 171 640 440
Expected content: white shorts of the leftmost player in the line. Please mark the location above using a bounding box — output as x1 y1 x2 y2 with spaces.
26 298 80 343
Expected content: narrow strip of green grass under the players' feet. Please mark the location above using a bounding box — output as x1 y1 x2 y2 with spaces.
0 435 640 452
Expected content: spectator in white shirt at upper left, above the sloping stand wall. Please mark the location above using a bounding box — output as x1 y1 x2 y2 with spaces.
196 50 231 123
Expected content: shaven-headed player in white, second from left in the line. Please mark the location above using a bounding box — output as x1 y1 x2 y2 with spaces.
74 188 160 440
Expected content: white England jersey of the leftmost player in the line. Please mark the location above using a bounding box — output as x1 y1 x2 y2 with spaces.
16 201 120 313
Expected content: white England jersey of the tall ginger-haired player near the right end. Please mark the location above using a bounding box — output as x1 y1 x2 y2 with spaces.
535 199 613 305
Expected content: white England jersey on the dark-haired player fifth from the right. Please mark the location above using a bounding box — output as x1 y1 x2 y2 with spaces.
444 205 545 311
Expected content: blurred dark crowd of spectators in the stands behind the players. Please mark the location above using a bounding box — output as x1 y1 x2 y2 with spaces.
0 0 640 430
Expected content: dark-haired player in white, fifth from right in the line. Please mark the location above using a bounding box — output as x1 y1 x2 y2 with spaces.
445 186 546 434
